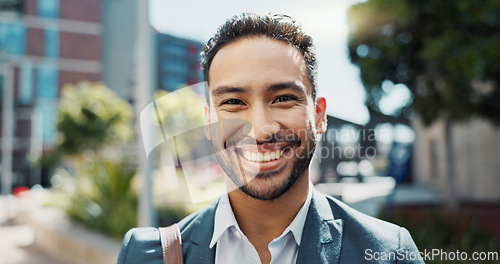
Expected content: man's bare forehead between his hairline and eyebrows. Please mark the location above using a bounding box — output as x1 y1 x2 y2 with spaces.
209 37 311 95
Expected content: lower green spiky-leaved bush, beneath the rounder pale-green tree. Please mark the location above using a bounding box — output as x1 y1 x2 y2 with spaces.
56 154 137 238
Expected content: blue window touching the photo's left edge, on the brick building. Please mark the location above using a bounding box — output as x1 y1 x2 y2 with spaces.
0 22 26 55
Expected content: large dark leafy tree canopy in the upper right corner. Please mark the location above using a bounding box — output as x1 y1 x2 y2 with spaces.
348 0 500 125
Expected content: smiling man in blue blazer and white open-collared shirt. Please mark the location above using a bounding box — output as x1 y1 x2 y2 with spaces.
118 14 420 263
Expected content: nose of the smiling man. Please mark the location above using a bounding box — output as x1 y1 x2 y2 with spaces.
247 107 280 141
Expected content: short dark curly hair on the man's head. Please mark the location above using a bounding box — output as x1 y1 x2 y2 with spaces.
201 13 317 100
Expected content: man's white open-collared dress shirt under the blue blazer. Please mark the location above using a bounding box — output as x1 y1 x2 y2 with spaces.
210 182 313 264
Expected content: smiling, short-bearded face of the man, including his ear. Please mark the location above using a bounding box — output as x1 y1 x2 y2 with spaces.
206 37 326 200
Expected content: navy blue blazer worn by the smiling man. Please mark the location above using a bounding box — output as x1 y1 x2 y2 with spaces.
118 189 424 264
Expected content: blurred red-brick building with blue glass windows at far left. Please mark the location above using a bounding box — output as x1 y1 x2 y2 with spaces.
0 0 102 186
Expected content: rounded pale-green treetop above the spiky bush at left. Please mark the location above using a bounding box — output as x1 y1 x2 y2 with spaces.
56 82 133 155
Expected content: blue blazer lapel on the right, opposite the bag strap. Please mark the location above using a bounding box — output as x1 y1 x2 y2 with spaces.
297 189 343 264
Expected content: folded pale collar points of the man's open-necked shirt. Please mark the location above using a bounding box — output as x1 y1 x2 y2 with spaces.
210 181 314 248
